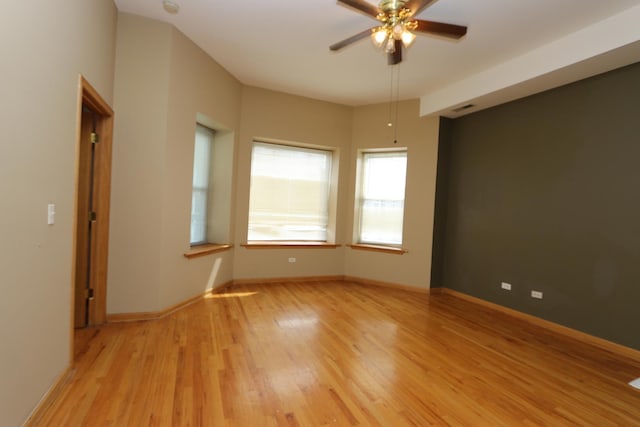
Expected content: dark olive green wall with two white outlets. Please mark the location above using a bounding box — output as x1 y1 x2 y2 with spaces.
438 64 640 349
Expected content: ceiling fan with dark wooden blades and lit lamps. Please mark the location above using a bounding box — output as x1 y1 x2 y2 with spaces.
329 0 467 65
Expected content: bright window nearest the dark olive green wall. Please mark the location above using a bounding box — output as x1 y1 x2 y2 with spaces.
355 150 407 247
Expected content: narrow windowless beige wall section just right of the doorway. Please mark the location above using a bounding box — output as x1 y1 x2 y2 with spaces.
107 13 173 313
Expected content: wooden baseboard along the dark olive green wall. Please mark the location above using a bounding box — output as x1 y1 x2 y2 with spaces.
438 288 640 361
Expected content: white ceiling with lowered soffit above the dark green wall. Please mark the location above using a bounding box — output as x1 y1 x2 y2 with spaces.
115 0 640 117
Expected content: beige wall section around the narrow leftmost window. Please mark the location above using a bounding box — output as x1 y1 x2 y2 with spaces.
160 22 241 308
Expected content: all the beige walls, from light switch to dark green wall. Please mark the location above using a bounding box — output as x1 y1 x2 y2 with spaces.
0 7 438 426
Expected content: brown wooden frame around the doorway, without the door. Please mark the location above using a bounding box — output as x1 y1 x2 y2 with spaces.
70 75 113 357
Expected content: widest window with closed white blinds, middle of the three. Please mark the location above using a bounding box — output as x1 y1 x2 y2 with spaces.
247 142 333 242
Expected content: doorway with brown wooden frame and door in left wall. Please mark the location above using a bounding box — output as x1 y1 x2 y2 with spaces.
71 76 113 332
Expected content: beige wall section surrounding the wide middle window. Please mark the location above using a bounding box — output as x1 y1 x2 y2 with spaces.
233 87 353 279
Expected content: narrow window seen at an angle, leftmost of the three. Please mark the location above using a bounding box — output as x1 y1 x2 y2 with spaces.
190 124 215 246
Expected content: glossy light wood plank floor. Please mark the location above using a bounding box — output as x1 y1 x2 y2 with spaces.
39 282 640 427
